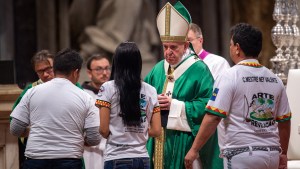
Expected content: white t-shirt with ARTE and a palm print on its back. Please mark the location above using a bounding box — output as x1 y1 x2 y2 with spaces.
206 59 291 150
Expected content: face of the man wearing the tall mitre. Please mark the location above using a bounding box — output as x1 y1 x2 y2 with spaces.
163 42 188 65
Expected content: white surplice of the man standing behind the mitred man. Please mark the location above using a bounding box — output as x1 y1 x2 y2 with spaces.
198 49 230 80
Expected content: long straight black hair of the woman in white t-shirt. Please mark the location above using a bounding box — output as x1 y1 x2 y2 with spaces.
110 42 142 126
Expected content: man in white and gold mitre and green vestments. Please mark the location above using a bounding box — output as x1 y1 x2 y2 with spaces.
145 1 223 169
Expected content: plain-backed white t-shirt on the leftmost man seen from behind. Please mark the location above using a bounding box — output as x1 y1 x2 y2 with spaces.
11 78 100 159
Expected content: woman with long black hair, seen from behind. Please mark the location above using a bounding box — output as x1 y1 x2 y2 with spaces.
96 42 161 169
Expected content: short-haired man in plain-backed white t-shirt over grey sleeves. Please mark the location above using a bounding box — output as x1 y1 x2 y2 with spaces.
10 49 100 169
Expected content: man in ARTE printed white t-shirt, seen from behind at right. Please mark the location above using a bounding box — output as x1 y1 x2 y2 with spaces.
185 23 291 169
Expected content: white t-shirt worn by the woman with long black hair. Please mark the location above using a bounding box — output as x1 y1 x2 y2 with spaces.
96 81 160 161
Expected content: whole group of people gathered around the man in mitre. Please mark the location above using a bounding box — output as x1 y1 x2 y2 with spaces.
10 1 291 169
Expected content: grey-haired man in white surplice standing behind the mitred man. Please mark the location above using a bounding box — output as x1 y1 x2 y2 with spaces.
188 23 230 80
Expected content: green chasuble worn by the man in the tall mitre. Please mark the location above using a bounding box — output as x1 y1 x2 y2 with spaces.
145 56 223 169
